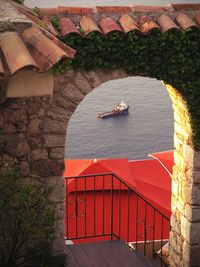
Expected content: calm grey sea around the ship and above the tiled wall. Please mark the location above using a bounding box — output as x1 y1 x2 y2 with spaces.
25 0 199 159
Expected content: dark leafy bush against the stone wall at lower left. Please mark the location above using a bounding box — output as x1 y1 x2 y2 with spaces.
0 171 66 267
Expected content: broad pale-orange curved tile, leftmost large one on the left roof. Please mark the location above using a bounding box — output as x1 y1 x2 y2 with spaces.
0 32 38 75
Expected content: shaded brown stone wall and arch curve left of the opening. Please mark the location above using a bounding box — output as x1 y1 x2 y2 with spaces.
0 70 126 254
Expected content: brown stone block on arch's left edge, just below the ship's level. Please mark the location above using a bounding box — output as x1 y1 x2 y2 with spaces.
43 118 67 134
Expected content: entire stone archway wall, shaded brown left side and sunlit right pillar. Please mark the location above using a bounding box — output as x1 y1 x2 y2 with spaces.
0 69 200 267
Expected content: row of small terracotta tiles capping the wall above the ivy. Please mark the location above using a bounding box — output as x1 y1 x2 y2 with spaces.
40 4 200 36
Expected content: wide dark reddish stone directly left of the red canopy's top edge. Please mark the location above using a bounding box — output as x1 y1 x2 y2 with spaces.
31 160 64 177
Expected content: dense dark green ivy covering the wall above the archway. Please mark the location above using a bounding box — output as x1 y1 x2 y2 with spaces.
50 17 200 150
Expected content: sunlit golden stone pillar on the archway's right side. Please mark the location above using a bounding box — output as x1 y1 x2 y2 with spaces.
167 86 200 267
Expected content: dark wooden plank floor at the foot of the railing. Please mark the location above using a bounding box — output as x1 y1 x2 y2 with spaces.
67 240 153 267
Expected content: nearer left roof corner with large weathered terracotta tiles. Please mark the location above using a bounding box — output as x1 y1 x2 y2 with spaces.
0 2 75 78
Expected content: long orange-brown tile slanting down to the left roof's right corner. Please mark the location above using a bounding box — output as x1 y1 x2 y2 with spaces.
22 27 66 64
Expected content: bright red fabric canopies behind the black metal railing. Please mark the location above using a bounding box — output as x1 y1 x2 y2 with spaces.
64 152 173 244
